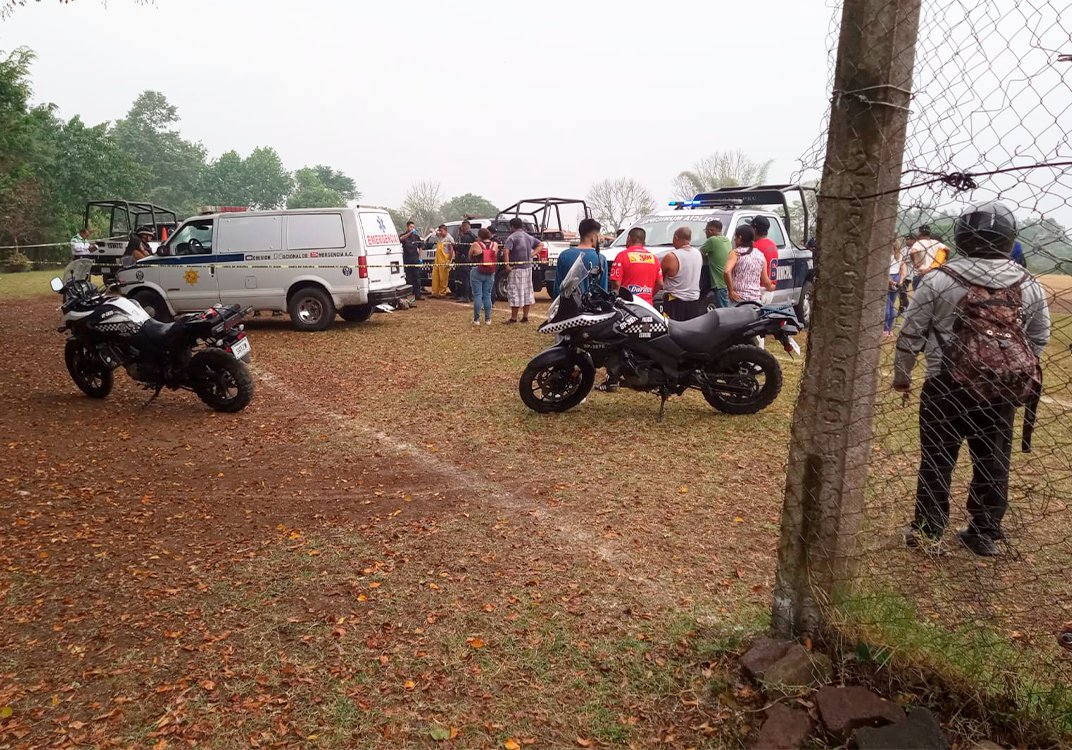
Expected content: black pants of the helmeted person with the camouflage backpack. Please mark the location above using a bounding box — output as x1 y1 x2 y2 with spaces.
914 378 1016 537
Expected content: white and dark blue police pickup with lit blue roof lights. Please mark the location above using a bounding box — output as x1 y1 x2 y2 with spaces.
601 184 815 326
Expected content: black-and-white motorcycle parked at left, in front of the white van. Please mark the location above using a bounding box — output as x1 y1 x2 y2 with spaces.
51 259 253 411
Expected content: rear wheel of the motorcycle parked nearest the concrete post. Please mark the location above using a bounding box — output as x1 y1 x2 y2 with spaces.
701 345 781 415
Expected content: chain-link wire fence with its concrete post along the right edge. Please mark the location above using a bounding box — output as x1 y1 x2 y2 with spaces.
775 0 1072 744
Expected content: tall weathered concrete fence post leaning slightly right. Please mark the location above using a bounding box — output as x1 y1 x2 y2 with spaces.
773 0 920 635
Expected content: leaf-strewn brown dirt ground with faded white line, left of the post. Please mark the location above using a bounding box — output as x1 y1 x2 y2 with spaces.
0 297 789 750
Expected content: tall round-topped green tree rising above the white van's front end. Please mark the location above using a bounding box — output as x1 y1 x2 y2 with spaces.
115 91 206 214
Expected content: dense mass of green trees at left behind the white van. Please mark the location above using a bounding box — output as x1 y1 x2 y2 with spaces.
0 47 361 245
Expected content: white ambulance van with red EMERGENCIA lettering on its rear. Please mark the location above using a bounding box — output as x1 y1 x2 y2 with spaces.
117 206 410 331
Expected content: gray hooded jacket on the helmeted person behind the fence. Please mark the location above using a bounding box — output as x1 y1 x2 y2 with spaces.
893 257 1049 386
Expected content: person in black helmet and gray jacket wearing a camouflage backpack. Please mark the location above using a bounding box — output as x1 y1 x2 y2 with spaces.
893 203 1049 556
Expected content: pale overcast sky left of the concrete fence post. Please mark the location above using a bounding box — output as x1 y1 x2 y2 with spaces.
0 0 832 211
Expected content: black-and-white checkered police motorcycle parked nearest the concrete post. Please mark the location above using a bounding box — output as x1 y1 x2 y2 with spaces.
519 258 801 419
